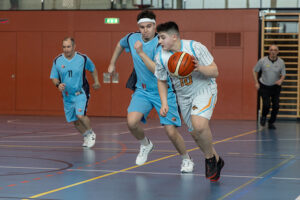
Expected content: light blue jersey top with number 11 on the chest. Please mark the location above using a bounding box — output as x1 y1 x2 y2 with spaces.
50 52 95 97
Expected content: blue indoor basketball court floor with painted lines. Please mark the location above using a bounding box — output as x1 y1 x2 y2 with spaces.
0 116 300 200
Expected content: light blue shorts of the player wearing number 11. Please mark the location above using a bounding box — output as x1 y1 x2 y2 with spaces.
63 93 88 122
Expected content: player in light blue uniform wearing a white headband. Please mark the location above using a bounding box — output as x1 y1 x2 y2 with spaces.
108 10 194 173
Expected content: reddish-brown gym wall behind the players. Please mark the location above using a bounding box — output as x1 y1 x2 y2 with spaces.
0 10 259 119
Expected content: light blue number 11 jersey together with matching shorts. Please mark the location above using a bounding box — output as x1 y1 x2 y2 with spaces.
50 53 95 122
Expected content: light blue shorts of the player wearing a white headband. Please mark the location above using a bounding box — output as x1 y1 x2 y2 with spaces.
127 89 181 126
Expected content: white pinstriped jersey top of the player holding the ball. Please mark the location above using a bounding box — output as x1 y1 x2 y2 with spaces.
155 40 217 105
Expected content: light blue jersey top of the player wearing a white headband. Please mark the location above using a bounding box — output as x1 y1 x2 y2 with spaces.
120 32 172 93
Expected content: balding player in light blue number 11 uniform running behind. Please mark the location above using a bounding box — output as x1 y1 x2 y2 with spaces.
50 37 100 148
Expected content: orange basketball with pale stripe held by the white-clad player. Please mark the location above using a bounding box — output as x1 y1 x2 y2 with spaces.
168 52 195 77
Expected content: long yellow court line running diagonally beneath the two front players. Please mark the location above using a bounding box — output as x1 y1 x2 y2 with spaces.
22 130 260 200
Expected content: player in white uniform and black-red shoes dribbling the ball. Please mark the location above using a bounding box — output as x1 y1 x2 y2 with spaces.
155 22 224 181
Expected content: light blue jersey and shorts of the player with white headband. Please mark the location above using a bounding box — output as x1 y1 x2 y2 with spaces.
120 32 181 126
